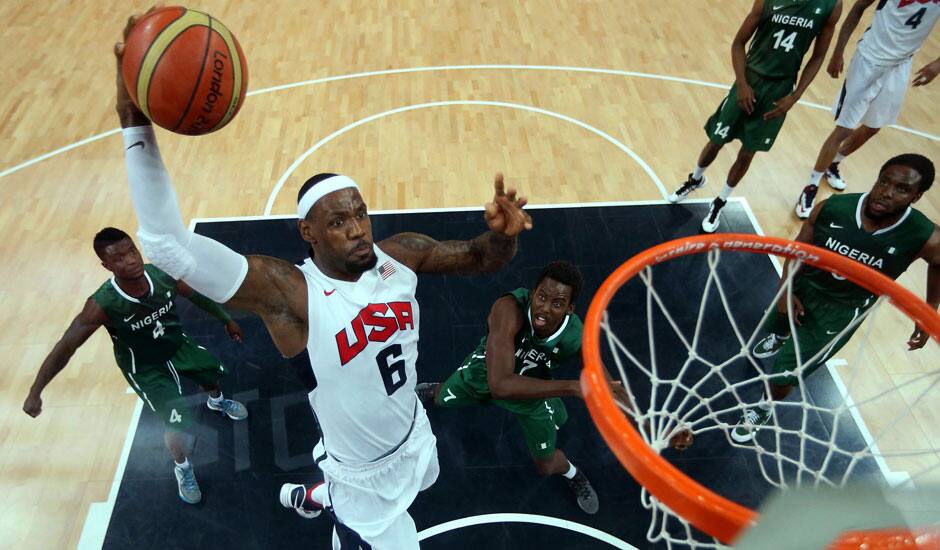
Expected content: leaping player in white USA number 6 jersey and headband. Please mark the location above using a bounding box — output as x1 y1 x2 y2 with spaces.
115 16 532 550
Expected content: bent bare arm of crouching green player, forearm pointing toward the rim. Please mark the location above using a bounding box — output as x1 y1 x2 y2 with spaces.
486 296 581 400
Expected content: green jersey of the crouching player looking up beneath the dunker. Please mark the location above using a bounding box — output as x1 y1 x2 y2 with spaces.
471 288 584 380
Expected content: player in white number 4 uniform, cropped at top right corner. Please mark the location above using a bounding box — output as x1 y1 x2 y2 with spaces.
796 0 940 219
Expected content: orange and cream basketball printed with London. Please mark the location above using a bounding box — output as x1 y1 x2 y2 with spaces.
121 6 248 136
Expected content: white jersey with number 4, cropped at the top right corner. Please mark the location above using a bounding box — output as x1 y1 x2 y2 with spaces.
857 0 940 65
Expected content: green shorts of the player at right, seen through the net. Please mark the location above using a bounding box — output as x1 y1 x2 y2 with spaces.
770 280 867 386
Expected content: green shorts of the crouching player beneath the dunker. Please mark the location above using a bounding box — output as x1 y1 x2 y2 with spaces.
437 355 568 458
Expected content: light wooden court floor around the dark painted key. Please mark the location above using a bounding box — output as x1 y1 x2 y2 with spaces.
0 0 940 548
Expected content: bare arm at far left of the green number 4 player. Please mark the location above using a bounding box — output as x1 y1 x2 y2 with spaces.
23 298 108 418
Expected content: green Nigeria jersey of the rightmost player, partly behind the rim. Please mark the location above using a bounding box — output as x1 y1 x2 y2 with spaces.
798 193 935 306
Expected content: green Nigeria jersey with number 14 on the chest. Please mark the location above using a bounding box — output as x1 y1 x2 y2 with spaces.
745 0 836 80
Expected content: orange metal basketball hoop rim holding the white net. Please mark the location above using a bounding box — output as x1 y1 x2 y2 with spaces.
581 233 940 548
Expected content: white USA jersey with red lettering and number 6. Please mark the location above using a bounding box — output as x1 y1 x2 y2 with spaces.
299 245 419 464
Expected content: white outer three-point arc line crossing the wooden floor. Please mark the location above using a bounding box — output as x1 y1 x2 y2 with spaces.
0 65 940 178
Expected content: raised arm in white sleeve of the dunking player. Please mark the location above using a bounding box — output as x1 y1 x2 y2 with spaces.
114 15 307 357
